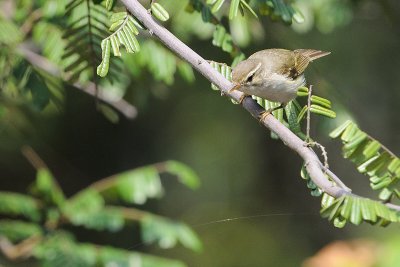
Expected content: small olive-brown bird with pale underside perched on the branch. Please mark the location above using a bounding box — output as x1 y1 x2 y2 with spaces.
229 48 330 119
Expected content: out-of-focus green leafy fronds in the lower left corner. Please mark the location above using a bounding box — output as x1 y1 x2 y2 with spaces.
0 161 201 267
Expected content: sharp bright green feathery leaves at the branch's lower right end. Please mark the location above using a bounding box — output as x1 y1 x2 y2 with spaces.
294 120 400 228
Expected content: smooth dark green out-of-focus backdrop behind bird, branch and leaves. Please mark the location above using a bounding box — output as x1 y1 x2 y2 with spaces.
0 0 400 267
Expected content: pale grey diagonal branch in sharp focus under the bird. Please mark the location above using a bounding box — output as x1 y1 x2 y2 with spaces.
121 0 400 214
